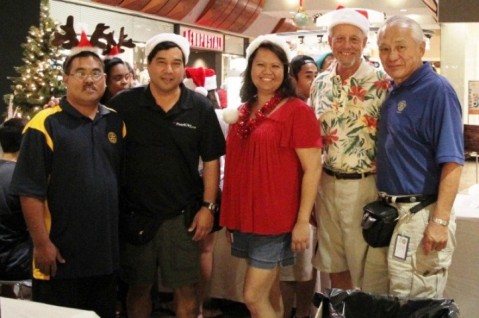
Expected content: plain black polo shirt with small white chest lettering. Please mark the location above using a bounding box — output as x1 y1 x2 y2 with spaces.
108 84 225 219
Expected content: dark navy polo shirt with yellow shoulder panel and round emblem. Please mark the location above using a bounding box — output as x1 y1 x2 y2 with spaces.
11 98 126 278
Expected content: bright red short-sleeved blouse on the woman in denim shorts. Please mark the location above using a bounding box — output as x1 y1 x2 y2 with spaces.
220 98 322 235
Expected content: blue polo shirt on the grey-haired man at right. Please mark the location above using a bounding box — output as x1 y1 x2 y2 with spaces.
376 63 464 195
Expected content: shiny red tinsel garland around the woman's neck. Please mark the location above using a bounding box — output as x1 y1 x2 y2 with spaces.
237 93 283 139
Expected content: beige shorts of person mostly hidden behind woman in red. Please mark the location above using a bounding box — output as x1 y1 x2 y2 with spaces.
279 225 317 282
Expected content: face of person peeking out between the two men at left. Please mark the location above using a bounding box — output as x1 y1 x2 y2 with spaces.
101 57 131 104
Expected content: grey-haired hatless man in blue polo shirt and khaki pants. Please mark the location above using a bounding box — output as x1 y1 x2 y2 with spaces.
377 16 464 298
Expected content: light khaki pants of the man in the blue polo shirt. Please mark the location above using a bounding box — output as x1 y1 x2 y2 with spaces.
388 203 456 298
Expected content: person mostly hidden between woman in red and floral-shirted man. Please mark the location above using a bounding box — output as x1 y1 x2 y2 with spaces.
280 55 318 318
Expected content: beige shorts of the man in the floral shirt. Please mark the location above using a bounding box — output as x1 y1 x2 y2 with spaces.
313 173 377 287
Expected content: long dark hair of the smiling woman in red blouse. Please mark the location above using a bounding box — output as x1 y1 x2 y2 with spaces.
240 41 295 103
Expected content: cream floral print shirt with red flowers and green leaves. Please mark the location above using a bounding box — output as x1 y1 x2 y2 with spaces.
310 60 390 173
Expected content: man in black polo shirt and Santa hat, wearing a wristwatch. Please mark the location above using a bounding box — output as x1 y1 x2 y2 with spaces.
109 34 225 318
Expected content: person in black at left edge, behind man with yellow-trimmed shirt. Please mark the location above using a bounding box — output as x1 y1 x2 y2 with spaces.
0 118 33 298
